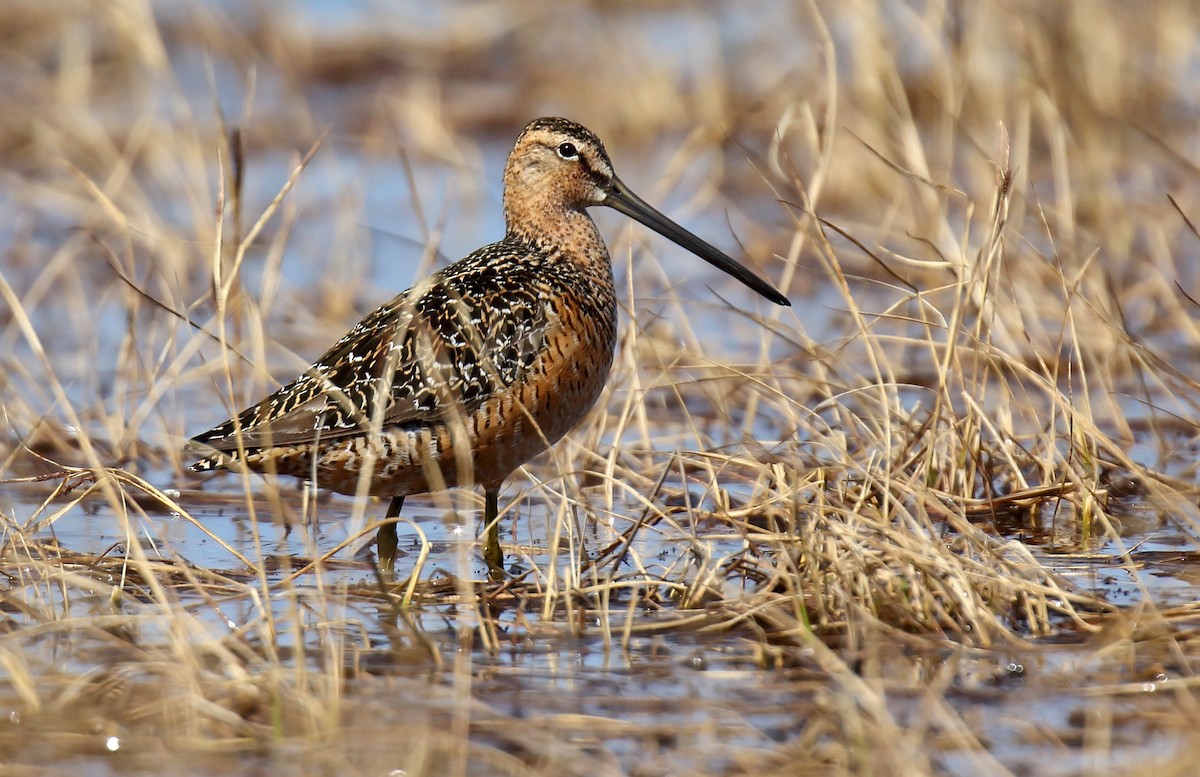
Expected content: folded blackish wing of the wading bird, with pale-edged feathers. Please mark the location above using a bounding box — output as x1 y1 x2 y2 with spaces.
188 247 558 451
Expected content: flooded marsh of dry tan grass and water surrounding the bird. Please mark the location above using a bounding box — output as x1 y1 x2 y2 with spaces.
0 0 1200 775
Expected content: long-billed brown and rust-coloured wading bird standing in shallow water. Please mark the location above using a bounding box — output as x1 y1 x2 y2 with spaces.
188 119 790 576
